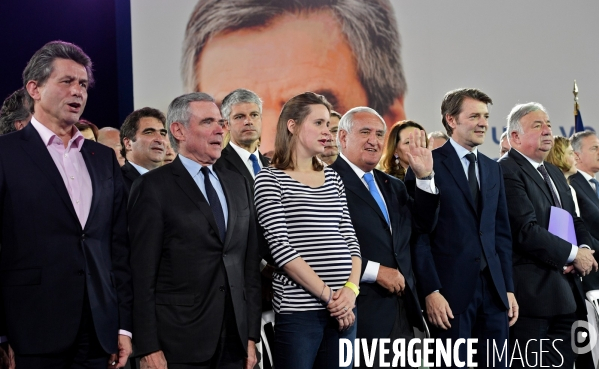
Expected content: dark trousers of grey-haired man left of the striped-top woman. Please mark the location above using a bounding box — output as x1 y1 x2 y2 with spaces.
166 292 247 369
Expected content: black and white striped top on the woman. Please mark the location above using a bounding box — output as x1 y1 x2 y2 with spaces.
254 167 360 313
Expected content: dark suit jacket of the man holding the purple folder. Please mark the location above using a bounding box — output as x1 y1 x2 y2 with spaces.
499 149 592 317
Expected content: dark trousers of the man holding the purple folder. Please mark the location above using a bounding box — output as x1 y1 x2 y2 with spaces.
510 313 578 368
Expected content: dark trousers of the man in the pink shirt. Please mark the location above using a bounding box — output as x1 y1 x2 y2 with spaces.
15 293 109 369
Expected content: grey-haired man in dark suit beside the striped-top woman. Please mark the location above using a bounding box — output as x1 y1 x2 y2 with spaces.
128 93 261 369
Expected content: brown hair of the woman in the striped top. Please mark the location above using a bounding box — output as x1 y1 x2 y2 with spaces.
271 92 332 171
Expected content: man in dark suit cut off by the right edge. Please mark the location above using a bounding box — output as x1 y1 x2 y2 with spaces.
568 131 599 292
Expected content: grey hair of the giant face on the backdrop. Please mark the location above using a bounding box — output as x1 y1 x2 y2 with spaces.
181 0 406 114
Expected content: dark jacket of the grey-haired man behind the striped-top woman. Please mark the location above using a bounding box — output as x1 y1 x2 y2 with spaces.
214 145 274 265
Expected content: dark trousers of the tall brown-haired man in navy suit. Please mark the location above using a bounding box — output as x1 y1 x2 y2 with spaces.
430 268 509 368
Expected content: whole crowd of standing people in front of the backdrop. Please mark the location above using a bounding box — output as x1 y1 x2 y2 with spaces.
0 41 599 369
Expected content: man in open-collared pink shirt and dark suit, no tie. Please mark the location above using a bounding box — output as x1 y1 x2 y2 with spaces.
0 41 132 368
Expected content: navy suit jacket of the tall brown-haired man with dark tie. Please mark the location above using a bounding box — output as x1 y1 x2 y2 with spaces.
406 141 514 314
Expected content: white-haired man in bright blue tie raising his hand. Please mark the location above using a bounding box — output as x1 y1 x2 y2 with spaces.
331 107 439 367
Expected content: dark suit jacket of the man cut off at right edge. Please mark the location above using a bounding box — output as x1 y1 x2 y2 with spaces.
568 172 599 291
